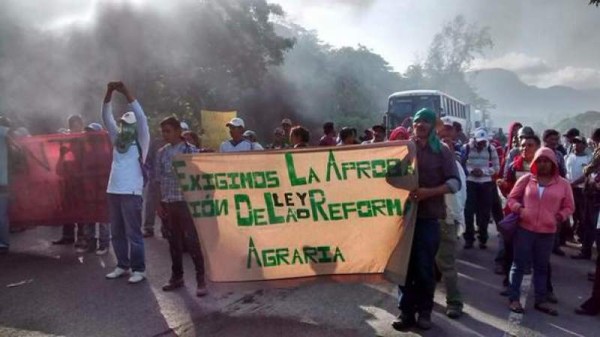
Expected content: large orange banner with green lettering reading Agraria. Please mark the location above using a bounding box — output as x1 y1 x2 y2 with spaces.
173 142 418 284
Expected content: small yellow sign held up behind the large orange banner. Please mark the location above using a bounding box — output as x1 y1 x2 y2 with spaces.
200 110 237 150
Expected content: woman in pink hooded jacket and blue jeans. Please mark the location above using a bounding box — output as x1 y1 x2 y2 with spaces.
508 147 575 316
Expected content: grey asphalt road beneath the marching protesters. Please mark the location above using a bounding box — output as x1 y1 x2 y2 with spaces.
0 223 600 337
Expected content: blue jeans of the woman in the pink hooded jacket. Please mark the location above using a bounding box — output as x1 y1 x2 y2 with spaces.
509 227 555 303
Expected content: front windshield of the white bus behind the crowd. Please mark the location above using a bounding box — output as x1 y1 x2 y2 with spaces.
388 95 440 128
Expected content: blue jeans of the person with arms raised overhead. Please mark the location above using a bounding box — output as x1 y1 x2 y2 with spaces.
108 193 146 272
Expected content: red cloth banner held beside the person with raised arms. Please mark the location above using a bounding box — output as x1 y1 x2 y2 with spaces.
9 132 112 227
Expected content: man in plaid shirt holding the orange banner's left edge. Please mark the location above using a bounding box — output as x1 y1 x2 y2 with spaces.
155 117 208 297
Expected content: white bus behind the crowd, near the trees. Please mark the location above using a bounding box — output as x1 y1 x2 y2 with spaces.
384 90 471 135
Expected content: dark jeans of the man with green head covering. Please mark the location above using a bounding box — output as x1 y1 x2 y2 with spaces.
398 219 440 315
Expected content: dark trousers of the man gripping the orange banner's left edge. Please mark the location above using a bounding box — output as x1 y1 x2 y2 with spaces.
163 201 204 285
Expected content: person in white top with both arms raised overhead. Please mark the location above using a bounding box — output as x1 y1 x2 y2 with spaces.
102 82 150 283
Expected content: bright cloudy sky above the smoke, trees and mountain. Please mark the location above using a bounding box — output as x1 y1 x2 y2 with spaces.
273 0 600 89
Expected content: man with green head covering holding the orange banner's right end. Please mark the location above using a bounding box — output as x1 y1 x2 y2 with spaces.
392 109 461 330
